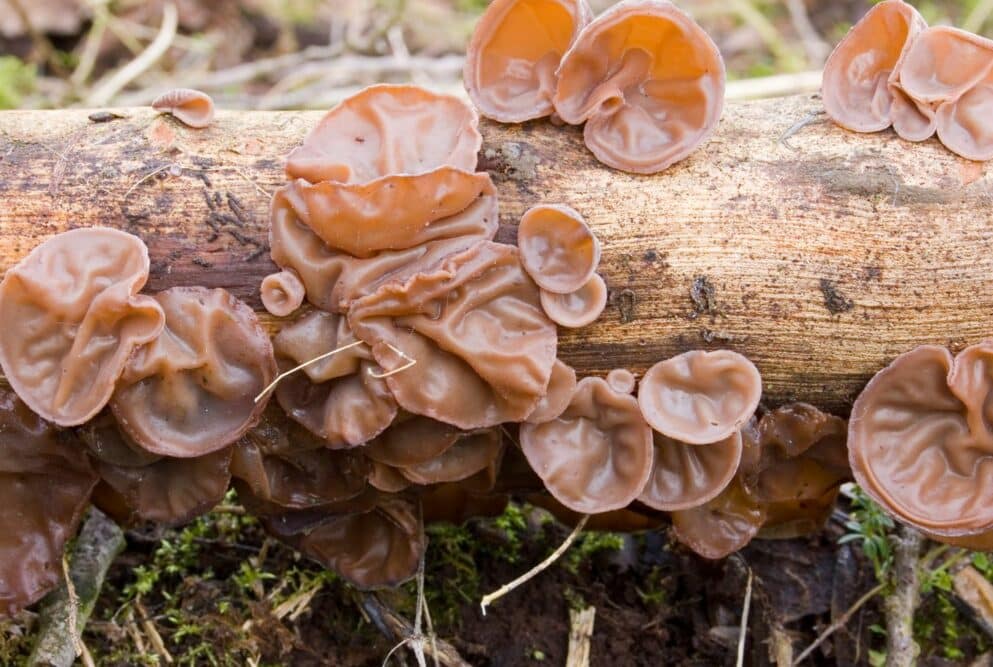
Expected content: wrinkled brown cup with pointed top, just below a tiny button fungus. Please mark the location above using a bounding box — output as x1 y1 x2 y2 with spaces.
520 378 652 514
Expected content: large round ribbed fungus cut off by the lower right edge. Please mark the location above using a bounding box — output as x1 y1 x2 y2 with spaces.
848 341 993 540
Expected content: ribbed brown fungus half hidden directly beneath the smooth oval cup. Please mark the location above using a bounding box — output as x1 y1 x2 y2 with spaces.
638 432 742 512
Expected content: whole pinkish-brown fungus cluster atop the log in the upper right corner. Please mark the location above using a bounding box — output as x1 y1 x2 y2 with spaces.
823 0 993 161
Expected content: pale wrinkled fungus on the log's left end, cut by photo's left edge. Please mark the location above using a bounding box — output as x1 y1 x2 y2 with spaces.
0 227 165 426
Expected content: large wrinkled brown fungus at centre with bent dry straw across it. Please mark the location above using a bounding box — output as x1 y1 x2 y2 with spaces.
348 242 558 430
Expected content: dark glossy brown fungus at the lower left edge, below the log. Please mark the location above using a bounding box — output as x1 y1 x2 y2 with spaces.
0 390 97 616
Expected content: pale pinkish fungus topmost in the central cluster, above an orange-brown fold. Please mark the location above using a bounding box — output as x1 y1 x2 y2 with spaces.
286 84 483 183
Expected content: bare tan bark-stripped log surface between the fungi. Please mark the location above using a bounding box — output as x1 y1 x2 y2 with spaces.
0 96 993 413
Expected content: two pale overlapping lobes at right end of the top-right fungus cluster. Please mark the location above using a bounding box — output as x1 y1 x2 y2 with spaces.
900 27 993 160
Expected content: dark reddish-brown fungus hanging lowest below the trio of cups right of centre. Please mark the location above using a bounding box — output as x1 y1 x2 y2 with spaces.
672 478 765 560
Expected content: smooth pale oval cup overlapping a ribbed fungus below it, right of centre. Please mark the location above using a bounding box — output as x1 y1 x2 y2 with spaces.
638 350 762 445
